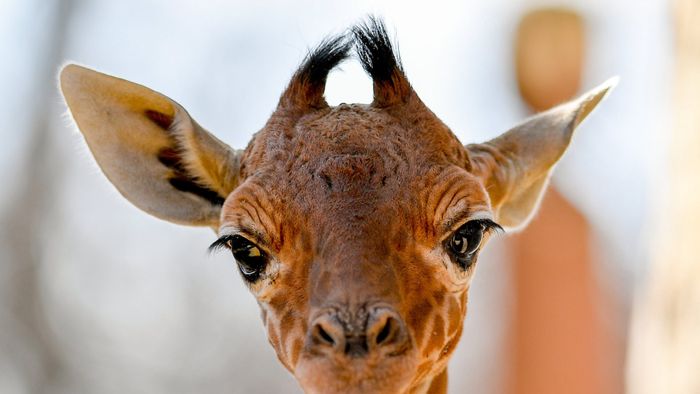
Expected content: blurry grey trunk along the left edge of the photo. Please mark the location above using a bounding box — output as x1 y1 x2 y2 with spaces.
0 0 74 393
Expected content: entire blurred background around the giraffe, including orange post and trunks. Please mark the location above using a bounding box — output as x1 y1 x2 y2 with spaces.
0 0 700 394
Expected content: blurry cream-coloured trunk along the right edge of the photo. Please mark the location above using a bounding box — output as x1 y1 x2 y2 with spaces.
627 0 700 394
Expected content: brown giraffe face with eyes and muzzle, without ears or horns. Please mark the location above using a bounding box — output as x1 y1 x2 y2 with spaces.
220 104 493 393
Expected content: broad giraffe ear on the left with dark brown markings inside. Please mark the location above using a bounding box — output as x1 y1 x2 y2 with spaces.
60 64 241 226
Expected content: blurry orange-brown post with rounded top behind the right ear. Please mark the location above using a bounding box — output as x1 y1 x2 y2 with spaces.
508 9 616 394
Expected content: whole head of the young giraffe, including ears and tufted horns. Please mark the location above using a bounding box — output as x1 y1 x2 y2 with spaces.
60 19 611 393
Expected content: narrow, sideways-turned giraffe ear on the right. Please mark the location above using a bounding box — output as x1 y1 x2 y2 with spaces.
467 77 618 228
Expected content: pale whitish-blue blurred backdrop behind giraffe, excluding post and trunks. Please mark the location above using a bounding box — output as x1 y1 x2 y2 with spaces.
0 0 672 394
